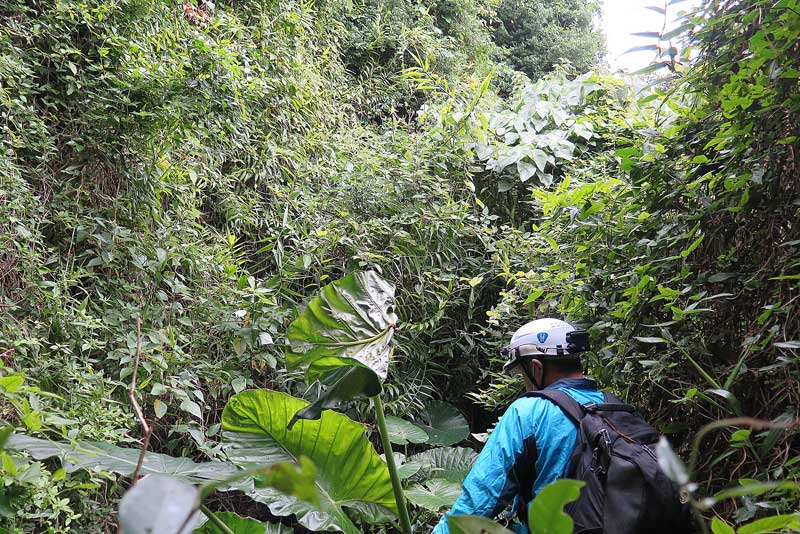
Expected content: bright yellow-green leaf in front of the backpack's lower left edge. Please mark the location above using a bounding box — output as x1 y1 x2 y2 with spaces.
528 478 586 534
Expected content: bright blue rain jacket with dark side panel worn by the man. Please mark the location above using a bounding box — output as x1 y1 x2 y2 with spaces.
433 378 603 534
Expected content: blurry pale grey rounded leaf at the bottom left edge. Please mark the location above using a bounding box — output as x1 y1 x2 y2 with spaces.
119 475 200 534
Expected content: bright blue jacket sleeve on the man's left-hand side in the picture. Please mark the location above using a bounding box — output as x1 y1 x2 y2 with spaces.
433 399 538 534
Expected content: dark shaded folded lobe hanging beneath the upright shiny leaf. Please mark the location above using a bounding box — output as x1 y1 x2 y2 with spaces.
289 365 382 432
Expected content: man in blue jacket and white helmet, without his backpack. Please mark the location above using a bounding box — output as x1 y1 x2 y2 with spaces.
433 319 604 534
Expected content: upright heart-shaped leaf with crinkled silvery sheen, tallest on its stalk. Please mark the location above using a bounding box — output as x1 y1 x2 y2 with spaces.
286 271 397 382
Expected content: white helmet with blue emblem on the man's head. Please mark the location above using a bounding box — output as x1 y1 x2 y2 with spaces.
500 319 589 369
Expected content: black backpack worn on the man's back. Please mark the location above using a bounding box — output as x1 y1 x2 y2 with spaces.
527 389 695 534
